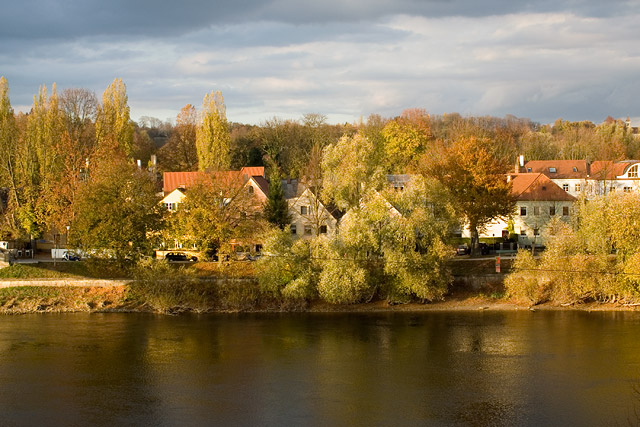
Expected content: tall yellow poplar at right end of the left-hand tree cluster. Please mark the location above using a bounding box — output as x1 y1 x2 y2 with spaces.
96 79 133 157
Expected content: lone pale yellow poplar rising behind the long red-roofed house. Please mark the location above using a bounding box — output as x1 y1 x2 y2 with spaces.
196 91 231 171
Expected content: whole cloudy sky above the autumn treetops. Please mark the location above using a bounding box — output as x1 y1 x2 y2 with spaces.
0 0 640 126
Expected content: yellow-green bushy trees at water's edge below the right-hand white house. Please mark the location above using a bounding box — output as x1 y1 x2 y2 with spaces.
506 193 640 304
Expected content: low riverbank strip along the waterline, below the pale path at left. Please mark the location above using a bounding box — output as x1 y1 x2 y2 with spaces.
0 280 640 314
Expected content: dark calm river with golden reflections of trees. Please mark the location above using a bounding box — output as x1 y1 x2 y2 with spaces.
0 311 640 426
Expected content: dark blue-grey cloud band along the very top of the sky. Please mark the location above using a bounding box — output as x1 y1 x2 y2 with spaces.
0 0 637 40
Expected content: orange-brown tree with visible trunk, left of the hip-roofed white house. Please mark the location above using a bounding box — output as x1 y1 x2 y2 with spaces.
419 137 515 253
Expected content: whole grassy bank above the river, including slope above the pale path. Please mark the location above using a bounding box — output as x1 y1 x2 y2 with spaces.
7 258 636 313
